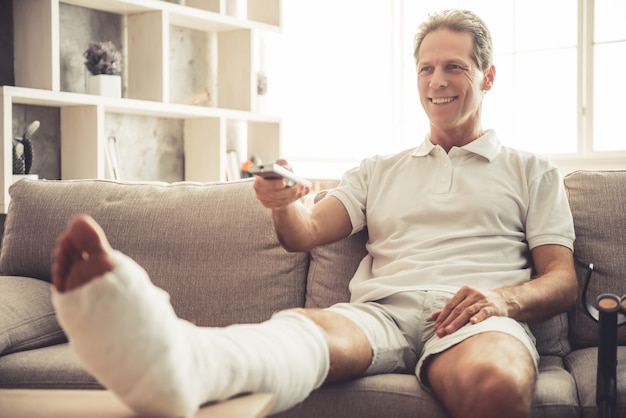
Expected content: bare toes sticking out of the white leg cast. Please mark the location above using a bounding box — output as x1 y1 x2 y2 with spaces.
52 215 115 292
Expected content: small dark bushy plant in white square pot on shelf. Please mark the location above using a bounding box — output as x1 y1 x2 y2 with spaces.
83 41 122 97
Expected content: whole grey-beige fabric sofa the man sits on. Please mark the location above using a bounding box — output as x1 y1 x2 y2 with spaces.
0 171 626 418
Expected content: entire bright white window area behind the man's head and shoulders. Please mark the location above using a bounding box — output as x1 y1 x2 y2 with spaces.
265 0 626 178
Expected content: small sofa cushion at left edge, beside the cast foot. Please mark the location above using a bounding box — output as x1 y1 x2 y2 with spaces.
0 276 67 355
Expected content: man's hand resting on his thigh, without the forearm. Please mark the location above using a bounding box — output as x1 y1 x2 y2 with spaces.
432 286 519 338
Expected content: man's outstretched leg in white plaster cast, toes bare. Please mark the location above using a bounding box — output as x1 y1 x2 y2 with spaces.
53 216 342 416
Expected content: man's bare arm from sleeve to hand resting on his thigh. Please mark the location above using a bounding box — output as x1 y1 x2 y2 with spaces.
433 245 578 337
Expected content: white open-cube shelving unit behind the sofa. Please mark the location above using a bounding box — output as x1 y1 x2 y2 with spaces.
0 0 281 212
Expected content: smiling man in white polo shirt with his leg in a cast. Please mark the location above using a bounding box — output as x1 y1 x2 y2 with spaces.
53 10 577 418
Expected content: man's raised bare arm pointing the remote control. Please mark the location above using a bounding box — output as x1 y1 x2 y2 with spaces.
254 177 352 252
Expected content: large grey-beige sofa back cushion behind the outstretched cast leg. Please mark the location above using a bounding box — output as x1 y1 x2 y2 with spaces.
0 180 309 326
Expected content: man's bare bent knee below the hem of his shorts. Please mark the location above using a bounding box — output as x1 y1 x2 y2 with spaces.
426 332 536 418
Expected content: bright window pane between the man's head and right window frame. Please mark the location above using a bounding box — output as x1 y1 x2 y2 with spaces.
405 0 578 154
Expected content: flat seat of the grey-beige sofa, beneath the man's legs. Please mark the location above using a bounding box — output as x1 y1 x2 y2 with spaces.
0 344 580 418
